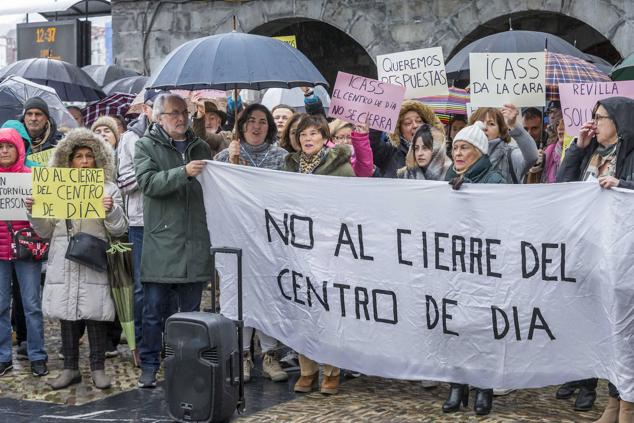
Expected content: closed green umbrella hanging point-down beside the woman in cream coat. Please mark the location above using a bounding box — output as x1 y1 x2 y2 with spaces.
106 241 136 361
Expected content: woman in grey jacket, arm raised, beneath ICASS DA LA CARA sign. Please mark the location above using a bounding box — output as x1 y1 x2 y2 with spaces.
469 104 538 184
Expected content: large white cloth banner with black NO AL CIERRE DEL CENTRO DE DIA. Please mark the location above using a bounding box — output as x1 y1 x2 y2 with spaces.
198 162 634 401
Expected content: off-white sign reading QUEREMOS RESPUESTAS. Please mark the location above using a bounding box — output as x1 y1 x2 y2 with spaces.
376 47 449 98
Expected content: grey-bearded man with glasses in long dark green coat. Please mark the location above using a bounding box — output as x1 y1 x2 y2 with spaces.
134 94 212 388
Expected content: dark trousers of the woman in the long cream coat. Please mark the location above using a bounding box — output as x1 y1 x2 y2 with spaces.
60 320 110 370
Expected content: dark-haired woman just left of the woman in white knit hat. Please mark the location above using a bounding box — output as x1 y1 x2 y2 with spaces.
397 124 451 181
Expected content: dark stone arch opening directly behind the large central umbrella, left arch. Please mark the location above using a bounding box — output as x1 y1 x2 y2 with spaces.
249 16 377 87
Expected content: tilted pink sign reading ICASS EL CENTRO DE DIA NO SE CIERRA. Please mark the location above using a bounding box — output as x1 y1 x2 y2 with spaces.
329 72 405 133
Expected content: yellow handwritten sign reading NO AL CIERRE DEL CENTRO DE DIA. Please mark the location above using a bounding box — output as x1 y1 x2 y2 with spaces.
32 167 106 219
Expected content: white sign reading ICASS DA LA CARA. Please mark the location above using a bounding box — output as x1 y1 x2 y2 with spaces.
469 52 546 107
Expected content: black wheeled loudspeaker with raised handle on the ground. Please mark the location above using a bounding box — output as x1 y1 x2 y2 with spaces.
164 248 244 422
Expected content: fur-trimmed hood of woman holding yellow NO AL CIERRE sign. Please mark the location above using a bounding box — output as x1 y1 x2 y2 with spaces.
48 128 115 182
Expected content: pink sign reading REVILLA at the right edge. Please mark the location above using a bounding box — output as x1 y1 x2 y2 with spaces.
559 81 634 137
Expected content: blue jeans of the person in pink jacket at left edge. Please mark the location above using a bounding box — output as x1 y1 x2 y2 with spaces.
0 260 48 363
